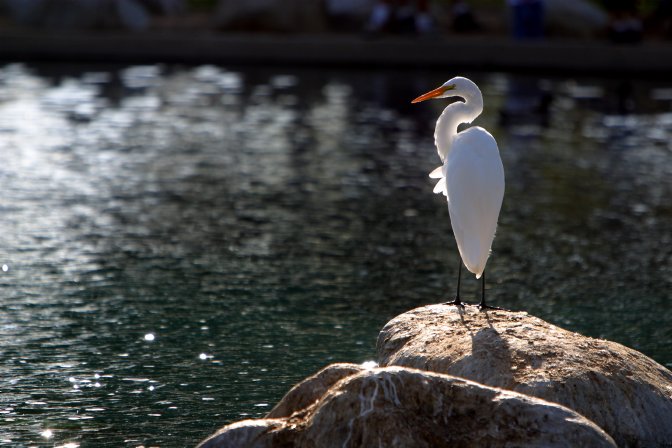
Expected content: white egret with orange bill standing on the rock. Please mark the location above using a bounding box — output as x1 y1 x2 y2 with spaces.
412 76 504 309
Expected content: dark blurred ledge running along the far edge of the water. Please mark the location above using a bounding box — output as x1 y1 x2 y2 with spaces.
0 28 672 77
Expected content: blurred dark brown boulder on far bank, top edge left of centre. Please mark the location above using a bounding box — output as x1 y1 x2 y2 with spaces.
215 0 327 33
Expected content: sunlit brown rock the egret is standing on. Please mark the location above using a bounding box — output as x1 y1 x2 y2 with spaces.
378 305 672 447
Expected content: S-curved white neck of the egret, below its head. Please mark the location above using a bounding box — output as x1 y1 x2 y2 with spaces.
434 93 483 162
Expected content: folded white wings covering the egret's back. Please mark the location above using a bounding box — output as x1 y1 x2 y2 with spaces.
445 127 504 278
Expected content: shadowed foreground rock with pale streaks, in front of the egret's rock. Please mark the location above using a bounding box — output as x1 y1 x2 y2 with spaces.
199 367 615 448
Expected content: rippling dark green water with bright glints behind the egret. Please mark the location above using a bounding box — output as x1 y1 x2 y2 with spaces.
0 65 672 447
